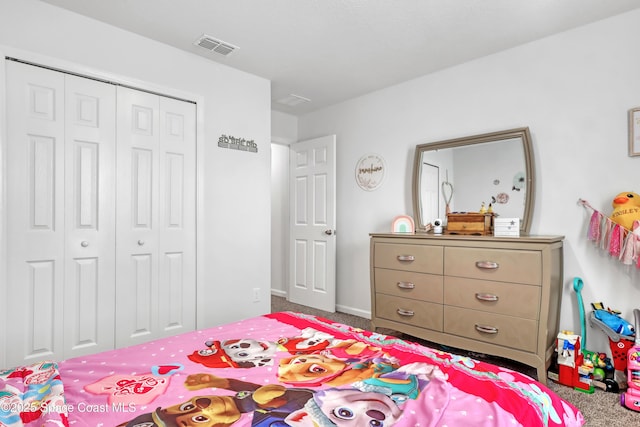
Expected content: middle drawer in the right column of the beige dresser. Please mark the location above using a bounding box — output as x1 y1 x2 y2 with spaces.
444 276 541 320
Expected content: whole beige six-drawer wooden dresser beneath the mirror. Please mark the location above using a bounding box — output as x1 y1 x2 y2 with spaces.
371 233 563 383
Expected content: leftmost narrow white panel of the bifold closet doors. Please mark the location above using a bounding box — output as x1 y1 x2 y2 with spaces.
6 61 65 365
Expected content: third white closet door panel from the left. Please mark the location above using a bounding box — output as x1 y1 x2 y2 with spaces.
116 87 160 347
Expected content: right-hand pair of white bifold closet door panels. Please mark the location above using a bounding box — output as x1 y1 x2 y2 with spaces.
116 87 196 347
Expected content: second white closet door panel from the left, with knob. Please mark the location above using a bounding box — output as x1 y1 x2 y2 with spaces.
64 75 116 357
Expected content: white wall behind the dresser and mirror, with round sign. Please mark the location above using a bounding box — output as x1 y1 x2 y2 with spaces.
299 11 640 351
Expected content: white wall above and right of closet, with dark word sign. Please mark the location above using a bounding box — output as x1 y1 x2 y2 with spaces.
0 0 271 327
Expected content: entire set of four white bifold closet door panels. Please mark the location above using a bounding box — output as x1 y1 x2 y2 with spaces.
5 61 196 365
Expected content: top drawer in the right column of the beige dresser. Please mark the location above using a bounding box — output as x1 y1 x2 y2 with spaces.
444 247 542 286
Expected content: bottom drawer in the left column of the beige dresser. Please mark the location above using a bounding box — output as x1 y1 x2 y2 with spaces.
376 294 442 331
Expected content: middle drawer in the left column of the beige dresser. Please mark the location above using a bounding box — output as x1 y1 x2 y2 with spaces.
374 268 443 304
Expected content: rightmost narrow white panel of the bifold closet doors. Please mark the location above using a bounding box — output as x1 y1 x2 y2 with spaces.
159 97 196 335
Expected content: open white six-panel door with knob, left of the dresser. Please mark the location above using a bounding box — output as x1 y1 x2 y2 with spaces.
288 135 336 312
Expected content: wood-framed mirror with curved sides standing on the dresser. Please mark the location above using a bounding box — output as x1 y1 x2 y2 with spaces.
413 127 535 235
